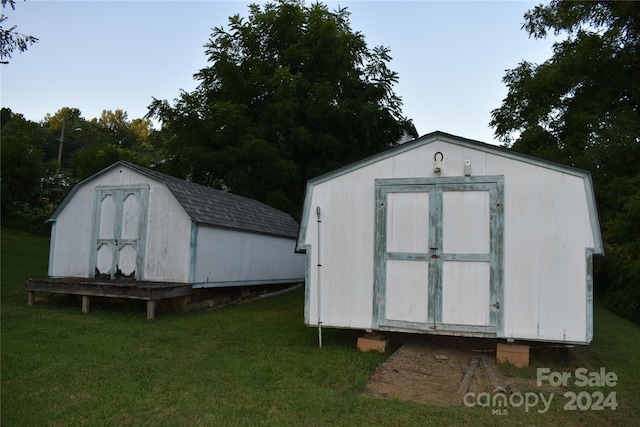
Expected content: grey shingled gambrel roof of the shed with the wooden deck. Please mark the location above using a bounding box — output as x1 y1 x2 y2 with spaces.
48 161 298 238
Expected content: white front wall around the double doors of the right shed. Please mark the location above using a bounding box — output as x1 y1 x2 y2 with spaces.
300 141 595 342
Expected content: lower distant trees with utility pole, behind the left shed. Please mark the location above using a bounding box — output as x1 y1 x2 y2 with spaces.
0 107 160 230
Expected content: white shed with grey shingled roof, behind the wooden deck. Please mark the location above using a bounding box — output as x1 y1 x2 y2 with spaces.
49 161 305 288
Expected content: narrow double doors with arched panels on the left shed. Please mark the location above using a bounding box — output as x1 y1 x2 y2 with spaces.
92 187 148 280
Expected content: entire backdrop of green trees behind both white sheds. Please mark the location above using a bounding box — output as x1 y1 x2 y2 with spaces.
1 0 640 320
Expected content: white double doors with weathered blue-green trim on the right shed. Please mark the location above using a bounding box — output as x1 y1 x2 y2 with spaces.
374 177 503 335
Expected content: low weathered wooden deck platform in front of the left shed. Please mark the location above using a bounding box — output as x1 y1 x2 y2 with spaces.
24 277 192 320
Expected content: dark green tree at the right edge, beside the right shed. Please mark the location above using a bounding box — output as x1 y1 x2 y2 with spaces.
491 0 640 319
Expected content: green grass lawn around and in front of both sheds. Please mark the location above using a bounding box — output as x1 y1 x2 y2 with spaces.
0 229 640 426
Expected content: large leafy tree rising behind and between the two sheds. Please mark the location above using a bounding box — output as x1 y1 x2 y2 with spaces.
148 0 408 215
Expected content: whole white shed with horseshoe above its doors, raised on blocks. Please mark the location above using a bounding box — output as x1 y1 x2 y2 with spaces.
298 132 603 344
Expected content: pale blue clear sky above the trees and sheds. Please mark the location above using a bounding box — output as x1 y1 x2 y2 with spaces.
0 0 553 144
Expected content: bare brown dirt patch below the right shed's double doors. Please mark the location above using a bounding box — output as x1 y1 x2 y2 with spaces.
365 336 544 406
